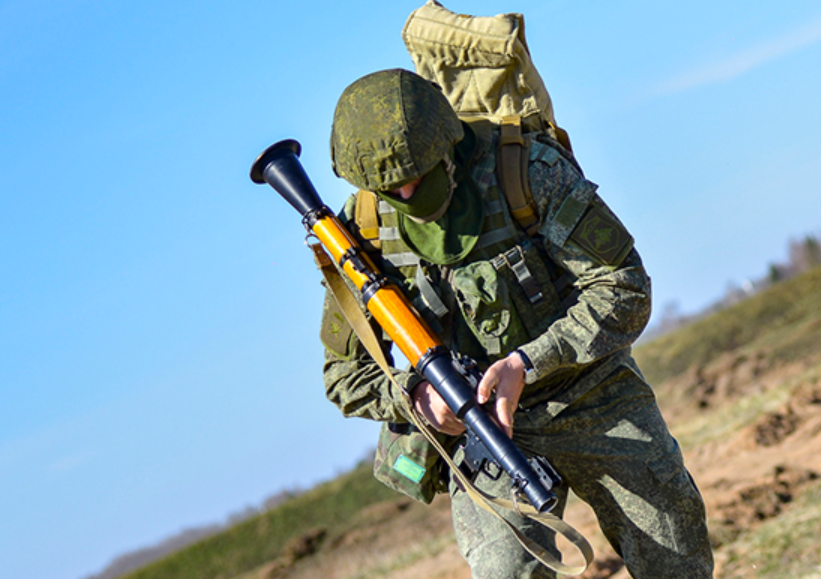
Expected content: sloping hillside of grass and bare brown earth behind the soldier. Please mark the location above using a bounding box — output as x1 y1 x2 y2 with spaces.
113 268 821 579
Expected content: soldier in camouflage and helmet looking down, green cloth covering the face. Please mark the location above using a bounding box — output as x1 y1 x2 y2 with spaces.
322 69 713 579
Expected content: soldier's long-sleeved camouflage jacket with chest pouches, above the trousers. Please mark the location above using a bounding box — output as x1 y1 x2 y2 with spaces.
322 125 650 422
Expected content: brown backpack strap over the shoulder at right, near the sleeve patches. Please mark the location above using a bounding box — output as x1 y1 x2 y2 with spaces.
496 116 539 236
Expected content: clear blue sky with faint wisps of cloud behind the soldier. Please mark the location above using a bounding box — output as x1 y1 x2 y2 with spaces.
0 0 821 579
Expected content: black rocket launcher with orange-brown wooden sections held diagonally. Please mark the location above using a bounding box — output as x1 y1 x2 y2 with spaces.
251 139 560 512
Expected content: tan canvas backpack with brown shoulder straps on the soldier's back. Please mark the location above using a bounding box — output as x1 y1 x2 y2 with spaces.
354 0 572 242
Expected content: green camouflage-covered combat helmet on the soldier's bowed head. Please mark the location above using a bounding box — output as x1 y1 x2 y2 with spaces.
331 68 464 192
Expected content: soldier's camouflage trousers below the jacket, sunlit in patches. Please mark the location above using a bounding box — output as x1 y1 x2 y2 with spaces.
451 367 713 579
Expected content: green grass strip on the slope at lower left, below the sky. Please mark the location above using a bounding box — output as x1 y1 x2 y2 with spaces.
118 464 397 579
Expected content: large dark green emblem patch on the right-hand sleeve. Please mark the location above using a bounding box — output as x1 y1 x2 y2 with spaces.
570 205 633 266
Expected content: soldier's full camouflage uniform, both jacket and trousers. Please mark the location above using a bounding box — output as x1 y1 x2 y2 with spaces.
323 70 712 579
